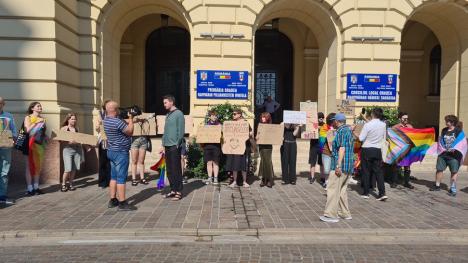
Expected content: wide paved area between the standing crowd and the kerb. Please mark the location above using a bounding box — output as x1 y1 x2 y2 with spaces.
0 171 468 231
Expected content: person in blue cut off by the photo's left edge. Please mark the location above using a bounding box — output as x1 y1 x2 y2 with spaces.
0 97 18 204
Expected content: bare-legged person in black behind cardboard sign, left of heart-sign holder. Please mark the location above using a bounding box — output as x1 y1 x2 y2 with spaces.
203 111 221 185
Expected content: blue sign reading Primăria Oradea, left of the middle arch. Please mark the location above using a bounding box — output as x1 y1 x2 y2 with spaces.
197 70 249 100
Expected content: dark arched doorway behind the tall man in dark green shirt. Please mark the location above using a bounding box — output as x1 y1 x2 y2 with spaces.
145 26 190 115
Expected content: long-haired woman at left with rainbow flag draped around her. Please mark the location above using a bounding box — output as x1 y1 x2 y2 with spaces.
23 101 47 196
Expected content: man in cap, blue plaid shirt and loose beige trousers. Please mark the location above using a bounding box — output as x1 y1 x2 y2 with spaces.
320 113 354 223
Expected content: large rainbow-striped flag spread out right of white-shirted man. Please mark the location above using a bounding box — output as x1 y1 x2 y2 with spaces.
398 128 435 166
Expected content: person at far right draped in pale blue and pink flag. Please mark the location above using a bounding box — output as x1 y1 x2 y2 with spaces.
430 115 466 196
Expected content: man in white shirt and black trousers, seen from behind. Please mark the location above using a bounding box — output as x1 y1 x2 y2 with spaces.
359 108 387 201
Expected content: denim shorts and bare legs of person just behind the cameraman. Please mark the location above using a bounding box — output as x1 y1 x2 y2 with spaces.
130 136 149 186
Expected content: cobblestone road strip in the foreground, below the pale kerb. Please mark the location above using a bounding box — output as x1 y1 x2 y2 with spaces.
0 243 468 263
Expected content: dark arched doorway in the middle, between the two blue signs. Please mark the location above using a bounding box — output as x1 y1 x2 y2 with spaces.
254 29 293 122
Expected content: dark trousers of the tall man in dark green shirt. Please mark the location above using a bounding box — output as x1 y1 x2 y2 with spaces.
165 145 183 193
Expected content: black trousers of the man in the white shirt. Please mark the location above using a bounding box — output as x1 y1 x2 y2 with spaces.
361 148 385 196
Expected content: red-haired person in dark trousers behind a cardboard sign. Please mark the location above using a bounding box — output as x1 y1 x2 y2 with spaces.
257 112 275 188
